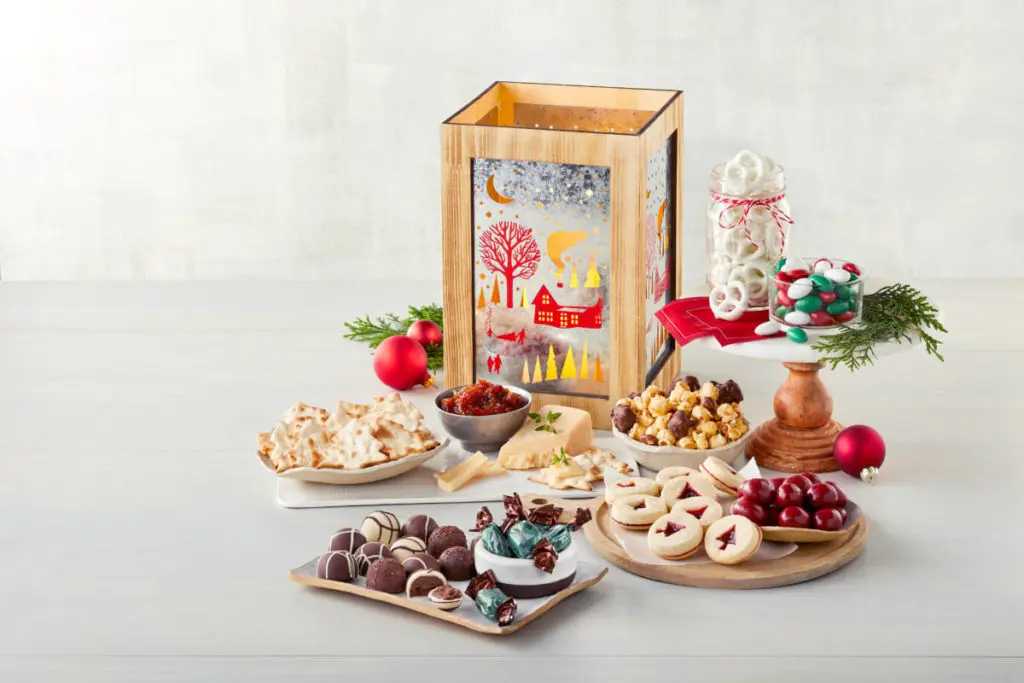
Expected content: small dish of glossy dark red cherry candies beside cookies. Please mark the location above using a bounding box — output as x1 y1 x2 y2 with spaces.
730 472 860 543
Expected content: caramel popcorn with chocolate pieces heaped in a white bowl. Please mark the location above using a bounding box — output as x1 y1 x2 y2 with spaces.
616 377 748 451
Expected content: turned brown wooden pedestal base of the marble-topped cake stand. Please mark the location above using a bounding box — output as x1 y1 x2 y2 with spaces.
746 362 843 472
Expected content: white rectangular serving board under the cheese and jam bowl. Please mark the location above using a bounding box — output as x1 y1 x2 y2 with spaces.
278 430 638 508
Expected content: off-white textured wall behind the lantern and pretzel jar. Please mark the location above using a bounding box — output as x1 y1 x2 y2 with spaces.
0 0 1024 282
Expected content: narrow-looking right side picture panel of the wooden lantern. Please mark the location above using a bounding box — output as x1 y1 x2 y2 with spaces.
644 139 676 384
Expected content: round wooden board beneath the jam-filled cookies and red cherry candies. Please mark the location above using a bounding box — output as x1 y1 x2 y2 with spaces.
584 502 867 590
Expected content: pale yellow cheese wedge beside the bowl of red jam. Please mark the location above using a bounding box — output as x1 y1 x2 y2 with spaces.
498 405 594 470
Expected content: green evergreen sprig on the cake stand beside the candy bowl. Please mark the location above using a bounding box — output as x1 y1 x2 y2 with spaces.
813 284 946 370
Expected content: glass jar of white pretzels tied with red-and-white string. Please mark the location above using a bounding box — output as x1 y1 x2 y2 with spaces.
706 151 793 310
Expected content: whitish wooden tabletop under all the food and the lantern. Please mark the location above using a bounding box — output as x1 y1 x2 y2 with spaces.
0 281 1024 682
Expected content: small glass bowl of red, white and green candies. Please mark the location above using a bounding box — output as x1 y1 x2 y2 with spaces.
755 257 861 344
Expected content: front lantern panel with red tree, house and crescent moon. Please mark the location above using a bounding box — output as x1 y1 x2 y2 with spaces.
473 159 611 398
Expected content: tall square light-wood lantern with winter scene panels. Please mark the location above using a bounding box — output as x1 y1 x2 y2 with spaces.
441 82 683 428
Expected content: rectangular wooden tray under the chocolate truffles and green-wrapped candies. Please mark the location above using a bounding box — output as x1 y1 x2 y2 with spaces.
288 557 608 636
